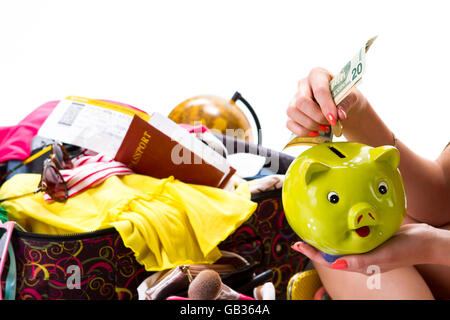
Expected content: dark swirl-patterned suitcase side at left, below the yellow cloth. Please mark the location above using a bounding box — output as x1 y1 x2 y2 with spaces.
2 228 151 300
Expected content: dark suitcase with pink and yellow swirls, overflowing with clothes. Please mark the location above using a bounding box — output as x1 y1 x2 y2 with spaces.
1 137 307 300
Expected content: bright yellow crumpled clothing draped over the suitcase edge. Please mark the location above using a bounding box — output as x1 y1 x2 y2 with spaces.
0 174 256 271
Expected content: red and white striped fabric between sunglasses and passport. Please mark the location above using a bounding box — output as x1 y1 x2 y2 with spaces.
44 151 135 201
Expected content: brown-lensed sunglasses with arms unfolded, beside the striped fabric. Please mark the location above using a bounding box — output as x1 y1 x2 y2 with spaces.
0 143 73 203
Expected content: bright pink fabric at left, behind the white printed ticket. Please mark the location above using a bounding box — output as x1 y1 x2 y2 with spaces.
0 99 149 163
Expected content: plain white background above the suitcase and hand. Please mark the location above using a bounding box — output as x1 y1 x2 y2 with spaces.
0 0 450 159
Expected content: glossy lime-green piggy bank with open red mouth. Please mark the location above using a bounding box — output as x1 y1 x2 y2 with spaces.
282 142 406 262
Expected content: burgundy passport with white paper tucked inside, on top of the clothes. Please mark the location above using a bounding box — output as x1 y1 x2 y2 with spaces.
115 113 236 188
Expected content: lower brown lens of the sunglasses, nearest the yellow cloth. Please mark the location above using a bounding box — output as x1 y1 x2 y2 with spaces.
41 162 68 202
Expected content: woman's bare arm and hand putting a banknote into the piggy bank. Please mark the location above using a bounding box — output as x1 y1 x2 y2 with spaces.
286 68 450 226
